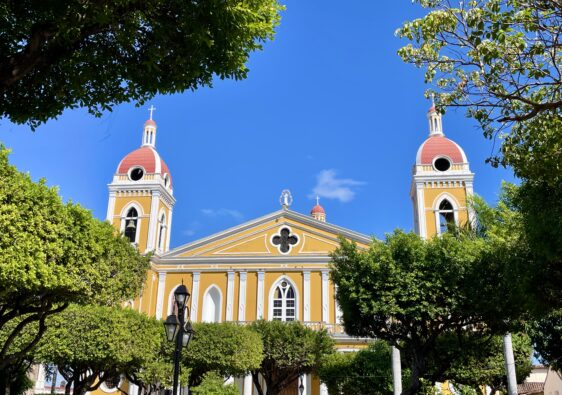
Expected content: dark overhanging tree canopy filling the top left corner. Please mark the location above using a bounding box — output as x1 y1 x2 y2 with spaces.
0 0 282 128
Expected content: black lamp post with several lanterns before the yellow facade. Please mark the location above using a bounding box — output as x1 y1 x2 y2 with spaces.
164 284 194 395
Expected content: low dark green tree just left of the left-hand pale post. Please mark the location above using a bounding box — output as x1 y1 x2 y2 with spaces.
318 340 396 395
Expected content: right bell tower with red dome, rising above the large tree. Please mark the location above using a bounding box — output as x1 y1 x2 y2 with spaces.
410 104 474 239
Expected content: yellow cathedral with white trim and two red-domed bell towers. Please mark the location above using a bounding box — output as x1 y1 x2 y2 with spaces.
99 106 474 395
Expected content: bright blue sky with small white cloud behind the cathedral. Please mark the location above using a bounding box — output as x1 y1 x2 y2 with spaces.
0 0 512 246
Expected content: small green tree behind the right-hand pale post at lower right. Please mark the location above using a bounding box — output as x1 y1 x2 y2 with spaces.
445 333 533 394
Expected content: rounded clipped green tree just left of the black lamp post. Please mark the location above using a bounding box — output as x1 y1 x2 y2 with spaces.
35 305 162 395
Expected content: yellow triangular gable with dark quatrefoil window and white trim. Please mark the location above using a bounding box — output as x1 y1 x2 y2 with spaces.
161 210 371 260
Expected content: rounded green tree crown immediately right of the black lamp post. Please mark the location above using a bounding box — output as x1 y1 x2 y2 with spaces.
184 322 263 386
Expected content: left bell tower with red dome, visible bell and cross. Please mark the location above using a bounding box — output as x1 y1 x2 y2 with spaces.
106 110 176 254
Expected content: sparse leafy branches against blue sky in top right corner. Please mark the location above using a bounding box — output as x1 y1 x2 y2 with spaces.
396 0 562 141
